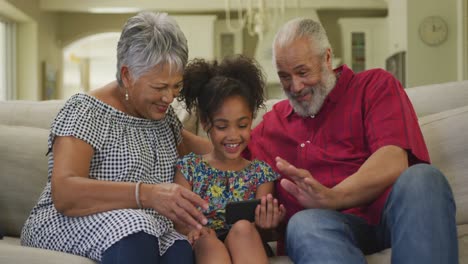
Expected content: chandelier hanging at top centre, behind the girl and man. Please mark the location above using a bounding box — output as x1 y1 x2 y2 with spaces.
224 0 299 39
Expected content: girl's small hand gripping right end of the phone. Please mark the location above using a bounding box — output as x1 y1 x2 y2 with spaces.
255 194 286 229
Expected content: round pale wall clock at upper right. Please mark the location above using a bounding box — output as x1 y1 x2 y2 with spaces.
419 16 448 46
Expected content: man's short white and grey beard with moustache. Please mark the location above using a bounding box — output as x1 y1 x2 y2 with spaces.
285 65 336 117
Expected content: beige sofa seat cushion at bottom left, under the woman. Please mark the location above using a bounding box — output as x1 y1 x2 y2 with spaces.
0 237 96 264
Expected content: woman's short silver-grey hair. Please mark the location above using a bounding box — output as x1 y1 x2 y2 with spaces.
116 12 188 87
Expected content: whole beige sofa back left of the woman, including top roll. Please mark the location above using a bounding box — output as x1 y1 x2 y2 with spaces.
0 100 68 237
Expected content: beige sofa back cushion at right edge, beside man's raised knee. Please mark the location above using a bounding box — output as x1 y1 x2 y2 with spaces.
419 106 468 224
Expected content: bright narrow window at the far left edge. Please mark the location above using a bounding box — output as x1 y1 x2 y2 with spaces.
0 19 16 100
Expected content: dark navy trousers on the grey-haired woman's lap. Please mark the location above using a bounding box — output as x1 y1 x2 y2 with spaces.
101 232 194 264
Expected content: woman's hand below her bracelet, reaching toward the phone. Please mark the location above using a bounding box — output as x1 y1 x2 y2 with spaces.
140 183 208 230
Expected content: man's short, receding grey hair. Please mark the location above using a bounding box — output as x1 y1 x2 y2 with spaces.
273 18 332 61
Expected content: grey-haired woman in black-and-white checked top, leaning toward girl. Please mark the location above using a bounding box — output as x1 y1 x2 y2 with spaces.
21 12 209 263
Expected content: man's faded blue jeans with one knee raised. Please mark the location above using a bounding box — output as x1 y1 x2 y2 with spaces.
286 164 458 264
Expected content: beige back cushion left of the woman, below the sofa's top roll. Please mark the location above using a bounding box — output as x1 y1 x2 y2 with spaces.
0 125 49 236
